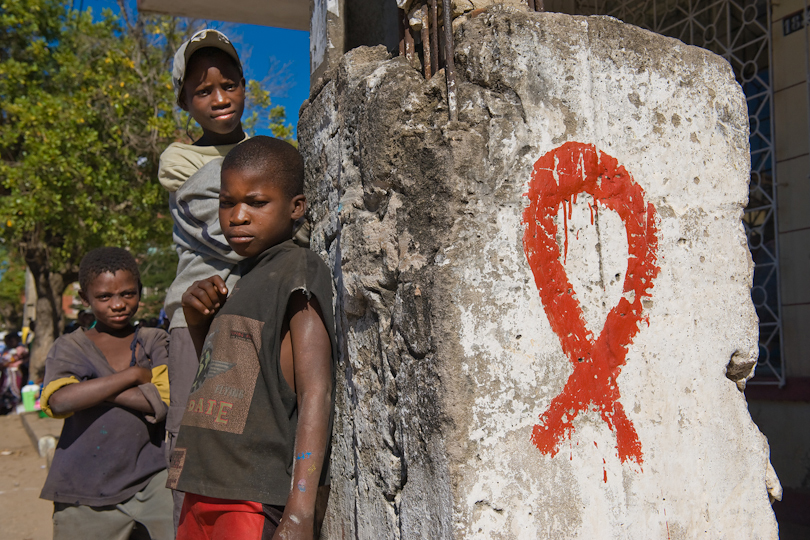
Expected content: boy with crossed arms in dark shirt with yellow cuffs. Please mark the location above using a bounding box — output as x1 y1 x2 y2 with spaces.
40 247 174 540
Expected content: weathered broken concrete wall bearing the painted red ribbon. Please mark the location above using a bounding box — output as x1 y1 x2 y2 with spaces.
299 7 779 539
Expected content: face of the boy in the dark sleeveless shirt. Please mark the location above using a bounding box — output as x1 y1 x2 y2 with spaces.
219 169 307 257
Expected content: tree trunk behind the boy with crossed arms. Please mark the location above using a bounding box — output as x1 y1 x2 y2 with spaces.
25 247 77 381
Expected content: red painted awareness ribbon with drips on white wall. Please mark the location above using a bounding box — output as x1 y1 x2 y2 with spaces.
523 142 659 465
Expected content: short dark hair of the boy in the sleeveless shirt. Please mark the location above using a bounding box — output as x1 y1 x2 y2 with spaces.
222 135 304 199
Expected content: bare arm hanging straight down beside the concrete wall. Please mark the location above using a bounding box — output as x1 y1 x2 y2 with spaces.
273 292 332 540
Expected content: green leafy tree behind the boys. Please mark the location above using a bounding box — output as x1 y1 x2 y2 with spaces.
0 0 294 378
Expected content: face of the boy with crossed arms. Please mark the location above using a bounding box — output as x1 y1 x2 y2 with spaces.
79 270 141 330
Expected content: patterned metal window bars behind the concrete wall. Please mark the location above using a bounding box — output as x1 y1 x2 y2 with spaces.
576 0 785 387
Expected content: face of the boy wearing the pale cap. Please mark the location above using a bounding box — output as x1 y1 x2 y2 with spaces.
180 52 245 144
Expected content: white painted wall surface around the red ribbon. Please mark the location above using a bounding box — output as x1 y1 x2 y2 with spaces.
452 8 778 539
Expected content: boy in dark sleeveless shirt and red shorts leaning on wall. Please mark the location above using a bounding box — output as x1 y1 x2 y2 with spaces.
169 136 336 540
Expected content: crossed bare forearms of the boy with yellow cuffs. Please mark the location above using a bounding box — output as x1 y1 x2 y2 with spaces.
48 366 154 416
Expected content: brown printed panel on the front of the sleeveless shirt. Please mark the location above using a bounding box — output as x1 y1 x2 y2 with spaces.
182 315 264 434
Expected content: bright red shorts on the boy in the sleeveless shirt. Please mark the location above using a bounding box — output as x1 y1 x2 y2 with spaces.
177 493 284 540
